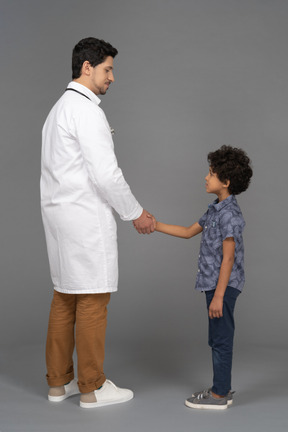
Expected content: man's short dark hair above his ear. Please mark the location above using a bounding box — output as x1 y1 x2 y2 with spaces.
72 37 118 79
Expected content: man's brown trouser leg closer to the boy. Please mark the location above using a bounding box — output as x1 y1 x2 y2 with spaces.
76 293 110 393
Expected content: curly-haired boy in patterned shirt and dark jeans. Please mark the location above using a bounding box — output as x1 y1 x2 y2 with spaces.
156 146 252 410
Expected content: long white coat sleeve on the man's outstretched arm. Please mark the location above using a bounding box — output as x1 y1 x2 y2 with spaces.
74 107 143 220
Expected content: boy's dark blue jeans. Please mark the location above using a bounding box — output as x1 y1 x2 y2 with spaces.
205 286 240 396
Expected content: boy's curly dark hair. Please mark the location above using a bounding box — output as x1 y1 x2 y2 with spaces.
207 145 253 195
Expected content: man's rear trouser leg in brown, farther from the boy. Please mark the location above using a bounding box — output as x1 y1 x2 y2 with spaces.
46 290 76 387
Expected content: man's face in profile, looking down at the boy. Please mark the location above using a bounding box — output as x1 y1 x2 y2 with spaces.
89 56 114 95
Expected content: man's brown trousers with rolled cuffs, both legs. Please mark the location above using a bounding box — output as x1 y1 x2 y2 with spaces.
46 290 110 393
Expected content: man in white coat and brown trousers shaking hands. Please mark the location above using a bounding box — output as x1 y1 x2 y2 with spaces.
41 38 155 408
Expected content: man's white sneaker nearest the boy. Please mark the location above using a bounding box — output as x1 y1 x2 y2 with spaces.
80 380 134 408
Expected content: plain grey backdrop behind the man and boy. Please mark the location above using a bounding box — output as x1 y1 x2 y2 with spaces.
0 0 288 432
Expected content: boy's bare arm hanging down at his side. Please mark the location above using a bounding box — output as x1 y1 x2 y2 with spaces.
209 237 235 319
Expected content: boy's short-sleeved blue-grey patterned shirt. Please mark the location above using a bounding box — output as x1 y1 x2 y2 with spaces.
195 195 245 291
